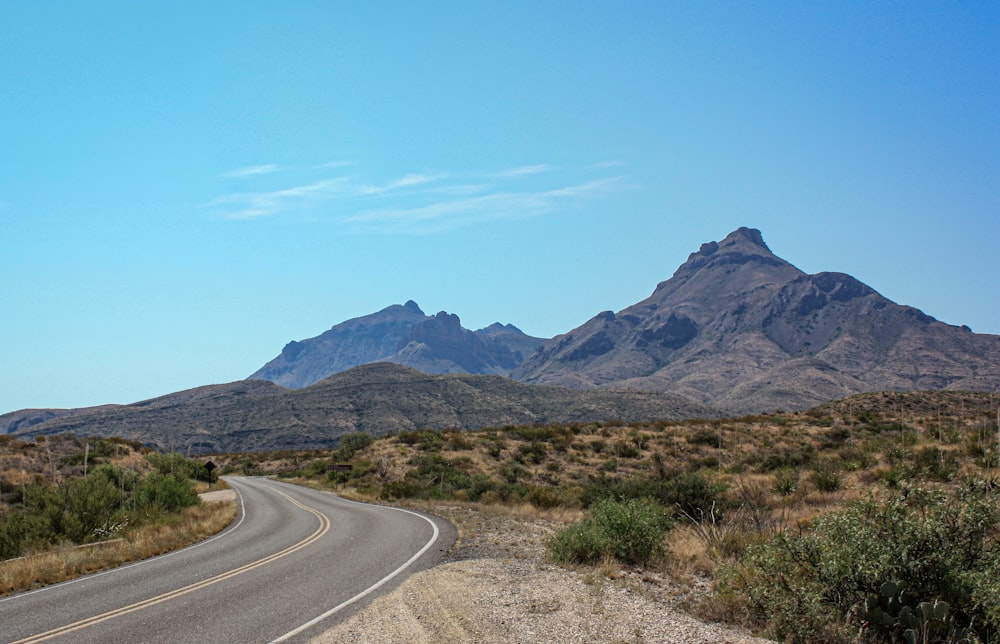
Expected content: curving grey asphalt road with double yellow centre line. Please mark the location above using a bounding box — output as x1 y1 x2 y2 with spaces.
0 477 455 644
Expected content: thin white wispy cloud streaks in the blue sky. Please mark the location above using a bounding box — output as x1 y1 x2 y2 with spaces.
210 162 629 234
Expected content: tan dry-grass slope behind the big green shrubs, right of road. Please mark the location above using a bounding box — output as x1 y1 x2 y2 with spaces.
216 392 1000 588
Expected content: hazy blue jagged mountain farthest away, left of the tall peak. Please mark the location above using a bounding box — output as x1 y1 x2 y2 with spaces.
249 300 543 389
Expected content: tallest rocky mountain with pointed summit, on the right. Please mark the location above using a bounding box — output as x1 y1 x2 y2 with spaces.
511 228 1000 412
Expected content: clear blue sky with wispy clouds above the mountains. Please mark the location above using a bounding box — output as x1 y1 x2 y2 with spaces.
0 0 1000 413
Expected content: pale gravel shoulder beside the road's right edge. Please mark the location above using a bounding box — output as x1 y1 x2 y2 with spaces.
313 505 767 644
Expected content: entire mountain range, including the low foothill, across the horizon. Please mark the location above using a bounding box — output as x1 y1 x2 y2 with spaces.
9 228 1000 451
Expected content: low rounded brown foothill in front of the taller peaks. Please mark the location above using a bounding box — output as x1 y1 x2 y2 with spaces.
13 363 719 453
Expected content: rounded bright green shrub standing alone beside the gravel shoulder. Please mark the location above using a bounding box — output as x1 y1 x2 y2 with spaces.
548 499 673 565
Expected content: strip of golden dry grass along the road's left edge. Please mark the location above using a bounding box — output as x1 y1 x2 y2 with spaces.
0 502 236 595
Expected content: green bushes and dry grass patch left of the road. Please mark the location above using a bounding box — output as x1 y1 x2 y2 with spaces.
0 435 235 592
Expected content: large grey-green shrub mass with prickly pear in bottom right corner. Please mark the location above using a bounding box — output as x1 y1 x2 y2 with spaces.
722 486 1000 641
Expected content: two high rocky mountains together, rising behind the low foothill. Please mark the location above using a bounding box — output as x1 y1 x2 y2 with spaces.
251 228 1000 413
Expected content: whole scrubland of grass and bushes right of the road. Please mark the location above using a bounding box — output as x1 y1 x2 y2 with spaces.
207 392 1000 641
